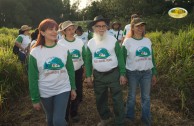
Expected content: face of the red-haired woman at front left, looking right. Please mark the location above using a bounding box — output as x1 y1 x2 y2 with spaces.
41 27 57 41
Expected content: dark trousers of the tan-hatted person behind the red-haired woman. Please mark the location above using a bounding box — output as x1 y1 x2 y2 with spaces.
66 67 83 120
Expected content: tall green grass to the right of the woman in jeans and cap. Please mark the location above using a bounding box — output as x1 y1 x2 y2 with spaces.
148 26 194 111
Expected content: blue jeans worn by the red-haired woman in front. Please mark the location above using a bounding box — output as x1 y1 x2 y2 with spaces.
41 91 70 126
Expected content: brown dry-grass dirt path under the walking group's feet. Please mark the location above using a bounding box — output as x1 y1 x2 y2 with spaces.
0 83 194 126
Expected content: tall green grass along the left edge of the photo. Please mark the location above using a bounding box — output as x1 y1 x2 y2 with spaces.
0 28 28 117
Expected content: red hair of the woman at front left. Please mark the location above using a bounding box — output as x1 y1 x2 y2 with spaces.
33 19 58 48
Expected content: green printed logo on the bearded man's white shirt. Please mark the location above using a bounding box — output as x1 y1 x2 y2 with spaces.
94 48 110 59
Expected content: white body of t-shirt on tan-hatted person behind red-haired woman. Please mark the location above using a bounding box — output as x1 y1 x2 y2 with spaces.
58 38 84 71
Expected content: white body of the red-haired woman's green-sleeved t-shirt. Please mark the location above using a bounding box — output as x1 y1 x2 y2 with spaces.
30 45 71 98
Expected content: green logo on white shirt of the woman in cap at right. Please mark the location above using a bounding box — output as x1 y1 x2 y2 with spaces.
136 47 151 57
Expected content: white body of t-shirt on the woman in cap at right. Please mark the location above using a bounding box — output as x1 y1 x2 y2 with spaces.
123 38 154 71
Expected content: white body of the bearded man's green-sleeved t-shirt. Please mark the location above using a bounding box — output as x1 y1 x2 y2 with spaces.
88 35 118 72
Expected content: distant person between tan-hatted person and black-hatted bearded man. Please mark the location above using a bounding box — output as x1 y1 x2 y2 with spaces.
75 26 88 48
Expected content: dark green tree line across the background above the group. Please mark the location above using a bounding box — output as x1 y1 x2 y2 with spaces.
0 0 194 27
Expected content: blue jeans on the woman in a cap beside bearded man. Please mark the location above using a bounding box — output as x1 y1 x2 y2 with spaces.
126 70 152 126
